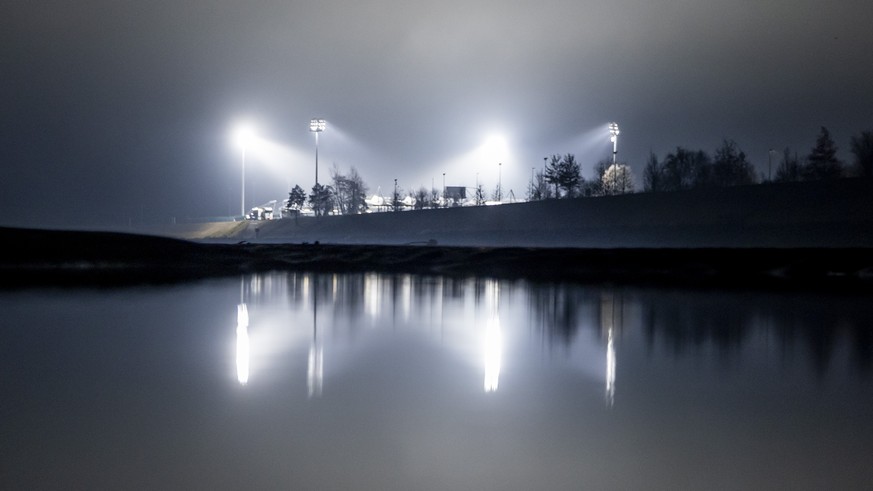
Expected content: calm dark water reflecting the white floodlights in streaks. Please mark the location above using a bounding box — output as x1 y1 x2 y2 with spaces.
0 273 873 490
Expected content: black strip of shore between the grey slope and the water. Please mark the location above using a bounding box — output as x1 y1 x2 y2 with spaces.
0 227 873 292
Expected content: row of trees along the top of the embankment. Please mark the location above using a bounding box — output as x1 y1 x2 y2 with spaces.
285 127 873 216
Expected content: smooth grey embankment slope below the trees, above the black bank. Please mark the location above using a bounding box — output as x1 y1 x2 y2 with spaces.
171 179 873 248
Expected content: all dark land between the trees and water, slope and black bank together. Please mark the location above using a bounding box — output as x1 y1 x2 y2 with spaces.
6 180 873 291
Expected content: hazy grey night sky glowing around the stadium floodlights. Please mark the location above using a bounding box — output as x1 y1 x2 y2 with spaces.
0 0 873 227
